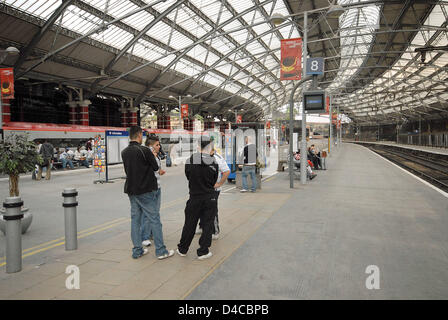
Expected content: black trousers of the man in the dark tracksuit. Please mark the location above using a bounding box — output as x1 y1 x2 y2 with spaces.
177 196 216 256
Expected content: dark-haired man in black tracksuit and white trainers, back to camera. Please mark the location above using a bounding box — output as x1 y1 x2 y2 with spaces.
177 137 219 260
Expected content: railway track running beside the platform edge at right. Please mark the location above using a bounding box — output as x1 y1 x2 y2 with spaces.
367 145 448 192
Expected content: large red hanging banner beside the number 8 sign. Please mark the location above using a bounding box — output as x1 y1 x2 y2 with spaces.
280 38 302 80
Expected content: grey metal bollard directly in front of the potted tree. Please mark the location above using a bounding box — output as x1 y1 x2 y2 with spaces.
3 197 23 273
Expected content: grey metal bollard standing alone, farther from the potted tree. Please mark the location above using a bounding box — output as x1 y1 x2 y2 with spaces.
62 188 78 250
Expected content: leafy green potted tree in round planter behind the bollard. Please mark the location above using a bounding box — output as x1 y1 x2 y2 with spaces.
0 134 43 233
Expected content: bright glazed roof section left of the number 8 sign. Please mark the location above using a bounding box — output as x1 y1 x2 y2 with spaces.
2 0 299 117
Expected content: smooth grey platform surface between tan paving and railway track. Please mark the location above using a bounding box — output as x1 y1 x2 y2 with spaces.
188 144 448 299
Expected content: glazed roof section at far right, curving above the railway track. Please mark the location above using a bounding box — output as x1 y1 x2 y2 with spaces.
331 2 448 122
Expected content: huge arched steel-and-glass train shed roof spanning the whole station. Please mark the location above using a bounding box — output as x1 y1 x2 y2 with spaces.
0 0 448 125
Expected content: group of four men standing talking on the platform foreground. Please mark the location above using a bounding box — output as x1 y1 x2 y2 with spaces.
121 126 230 260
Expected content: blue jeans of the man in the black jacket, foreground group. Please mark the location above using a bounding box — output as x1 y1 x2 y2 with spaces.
128 191 168 258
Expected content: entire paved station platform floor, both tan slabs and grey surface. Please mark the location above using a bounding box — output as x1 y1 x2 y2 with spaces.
0 143 448 300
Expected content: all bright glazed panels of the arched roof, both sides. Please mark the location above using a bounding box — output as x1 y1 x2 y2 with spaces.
1 0 448 122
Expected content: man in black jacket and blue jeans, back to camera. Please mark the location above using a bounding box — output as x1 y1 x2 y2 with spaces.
121 126 174 259
